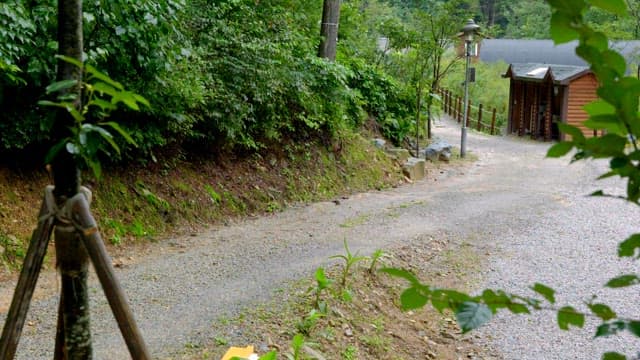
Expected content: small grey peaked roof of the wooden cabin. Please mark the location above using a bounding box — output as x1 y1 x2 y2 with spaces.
504 63 591 85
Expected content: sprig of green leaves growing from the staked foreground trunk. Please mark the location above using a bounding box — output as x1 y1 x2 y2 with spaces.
38 55 150 177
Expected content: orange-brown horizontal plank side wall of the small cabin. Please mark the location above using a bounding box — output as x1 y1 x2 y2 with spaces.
565 74 598 137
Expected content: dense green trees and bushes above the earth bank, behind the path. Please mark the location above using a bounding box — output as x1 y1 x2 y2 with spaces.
0 0 640 166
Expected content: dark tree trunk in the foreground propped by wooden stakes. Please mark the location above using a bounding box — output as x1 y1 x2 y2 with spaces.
51 0 93 360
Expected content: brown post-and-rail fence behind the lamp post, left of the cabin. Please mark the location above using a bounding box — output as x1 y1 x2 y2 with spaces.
438 88 505 135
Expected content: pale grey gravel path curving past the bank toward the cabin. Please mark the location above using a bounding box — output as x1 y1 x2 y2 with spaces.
0 116 640 359
